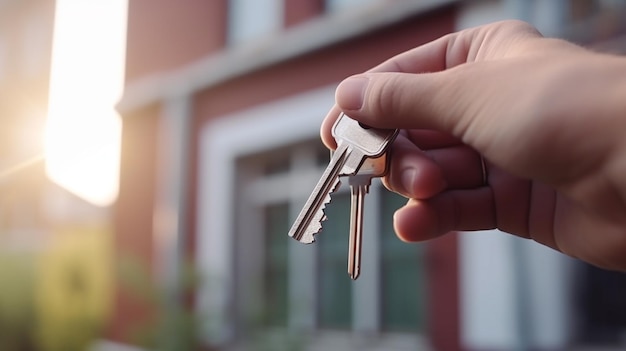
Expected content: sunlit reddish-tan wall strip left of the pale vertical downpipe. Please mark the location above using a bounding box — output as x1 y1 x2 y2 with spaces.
108 106 159 342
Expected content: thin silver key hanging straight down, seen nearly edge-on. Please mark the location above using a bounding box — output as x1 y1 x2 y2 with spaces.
348 153 389 280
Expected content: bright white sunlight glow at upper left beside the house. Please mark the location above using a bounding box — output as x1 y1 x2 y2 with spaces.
45 0 128 206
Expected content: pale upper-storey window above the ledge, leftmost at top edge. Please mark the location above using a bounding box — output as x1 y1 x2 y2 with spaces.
228 0 284 45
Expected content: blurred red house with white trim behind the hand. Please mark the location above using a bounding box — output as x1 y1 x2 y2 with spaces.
109 0 626 350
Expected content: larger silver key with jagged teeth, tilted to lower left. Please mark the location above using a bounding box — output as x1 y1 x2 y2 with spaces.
289 114 398 244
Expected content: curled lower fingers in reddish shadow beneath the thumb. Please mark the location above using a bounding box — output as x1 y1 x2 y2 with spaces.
385 142 494 242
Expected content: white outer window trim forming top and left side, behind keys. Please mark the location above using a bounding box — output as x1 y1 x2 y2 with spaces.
196 86 334 343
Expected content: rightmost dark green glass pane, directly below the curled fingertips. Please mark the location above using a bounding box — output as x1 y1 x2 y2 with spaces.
381 191 426 331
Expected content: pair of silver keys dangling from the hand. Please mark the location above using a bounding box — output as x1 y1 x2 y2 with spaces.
289 114 398 280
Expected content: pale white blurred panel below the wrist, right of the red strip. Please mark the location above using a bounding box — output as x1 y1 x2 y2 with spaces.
459 230 574 350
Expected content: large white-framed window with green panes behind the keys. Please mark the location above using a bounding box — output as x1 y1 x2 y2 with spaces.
198 87 426 349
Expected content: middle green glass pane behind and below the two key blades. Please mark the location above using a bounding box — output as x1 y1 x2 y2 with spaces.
316 193 352 329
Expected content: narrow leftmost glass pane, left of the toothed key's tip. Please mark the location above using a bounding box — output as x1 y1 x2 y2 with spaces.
263 204 289 326
